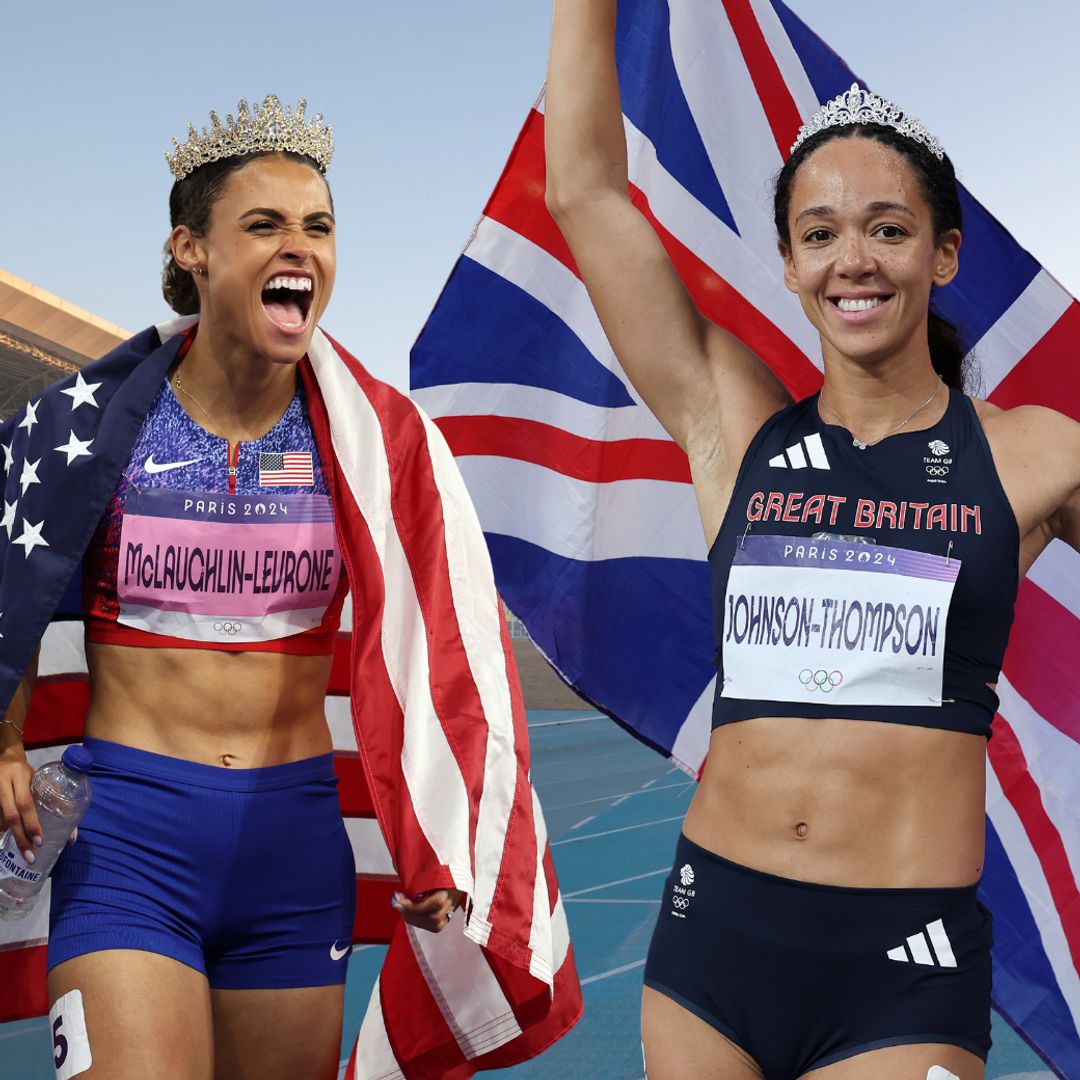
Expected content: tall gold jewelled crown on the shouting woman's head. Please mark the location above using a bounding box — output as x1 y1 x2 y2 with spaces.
165 94 334 180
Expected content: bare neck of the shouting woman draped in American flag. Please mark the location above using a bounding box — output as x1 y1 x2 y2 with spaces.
173 326 297 443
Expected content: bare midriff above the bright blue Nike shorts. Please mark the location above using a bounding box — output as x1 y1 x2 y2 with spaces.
86 643 333 769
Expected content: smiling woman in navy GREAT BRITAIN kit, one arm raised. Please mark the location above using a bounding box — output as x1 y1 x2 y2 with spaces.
545 0 1080 1080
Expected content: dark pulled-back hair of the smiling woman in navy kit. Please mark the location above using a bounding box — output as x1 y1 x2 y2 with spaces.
773 124 967 390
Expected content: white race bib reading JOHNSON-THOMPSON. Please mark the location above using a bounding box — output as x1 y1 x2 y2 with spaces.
720 536 960 705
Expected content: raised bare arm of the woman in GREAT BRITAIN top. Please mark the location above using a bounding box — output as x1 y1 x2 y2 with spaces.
544 0 788 494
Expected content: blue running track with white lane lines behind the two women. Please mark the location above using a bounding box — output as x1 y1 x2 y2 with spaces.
0 712 1053 1080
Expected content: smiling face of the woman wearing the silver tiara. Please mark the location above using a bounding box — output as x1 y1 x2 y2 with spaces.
780 137 960 373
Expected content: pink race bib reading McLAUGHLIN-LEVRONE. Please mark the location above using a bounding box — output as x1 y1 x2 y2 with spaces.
117 485 341 642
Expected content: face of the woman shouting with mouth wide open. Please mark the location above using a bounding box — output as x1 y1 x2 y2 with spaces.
172 154 337 364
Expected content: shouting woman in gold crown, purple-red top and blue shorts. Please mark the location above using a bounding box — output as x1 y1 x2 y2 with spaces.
0 97 460 1080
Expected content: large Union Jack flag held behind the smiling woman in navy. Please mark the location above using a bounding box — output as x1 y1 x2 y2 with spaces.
411 0 1080 1077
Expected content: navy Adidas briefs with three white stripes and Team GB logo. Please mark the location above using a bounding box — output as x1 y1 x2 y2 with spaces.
645 836 993 1080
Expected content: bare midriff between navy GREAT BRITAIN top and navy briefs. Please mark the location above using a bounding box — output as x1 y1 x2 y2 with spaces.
684 716 986 889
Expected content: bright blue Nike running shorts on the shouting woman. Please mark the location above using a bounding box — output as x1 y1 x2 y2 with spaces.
49 739 356 989
